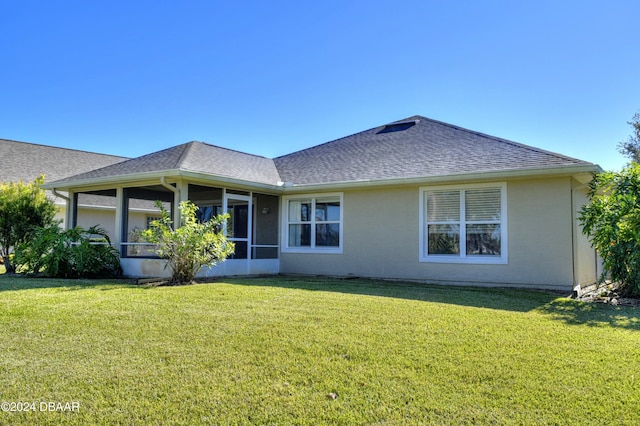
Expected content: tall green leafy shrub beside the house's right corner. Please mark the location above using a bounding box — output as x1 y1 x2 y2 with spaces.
580 162 640 295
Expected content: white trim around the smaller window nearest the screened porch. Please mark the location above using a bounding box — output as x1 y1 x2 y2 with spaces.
280 192 344 254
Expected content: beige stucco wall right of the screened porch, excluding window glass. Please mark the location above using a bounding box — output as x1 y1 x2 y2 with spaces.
280 176 599 290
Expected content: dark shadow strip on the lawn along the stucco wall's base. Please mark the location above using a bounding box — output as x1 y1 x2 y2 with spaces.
220 276 640 330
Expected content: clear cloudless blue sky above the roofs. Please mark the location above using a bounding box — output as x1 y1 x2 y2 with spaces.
0 0 640 169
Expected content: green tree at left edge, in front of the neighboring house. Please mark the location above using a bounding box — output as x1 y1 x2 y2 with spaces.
0 176 56 272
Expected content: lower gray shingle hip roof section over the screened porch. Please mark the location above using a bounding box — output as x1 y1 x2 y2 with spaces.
55 142 280 185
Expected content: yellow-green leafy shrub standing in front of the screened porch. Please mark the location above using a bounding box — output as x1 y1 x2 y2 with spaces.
141 201 234 284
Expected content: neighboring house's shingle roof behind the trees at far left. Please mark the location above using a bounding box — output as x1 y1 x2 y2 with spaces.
0 139 127 182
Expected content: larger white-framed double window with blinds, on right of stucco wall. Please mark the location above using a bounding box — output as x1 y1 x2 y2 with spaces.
420 182 508 264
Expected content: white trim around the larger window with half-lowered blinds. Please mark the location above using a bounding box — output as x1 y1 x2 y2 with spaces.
419 182 509 265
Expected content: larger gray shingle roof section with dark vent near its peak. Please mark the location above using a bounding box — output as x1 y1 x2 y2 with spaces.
274 116 595 185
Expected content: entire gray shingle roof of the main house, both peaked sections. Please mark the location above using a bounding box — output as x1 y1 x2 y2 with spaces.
47 115 599 189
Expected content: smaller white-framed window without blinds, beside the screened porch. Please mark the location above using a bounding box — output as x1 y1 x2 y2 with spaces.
282 193 343 253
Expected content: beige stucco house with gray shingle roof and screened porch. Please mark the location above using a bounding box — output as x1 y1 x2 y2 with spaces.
46 116 600 290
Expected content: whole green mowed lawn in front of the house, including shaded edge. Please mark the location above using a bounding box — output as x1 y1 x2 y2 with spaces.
0 276 640 425
